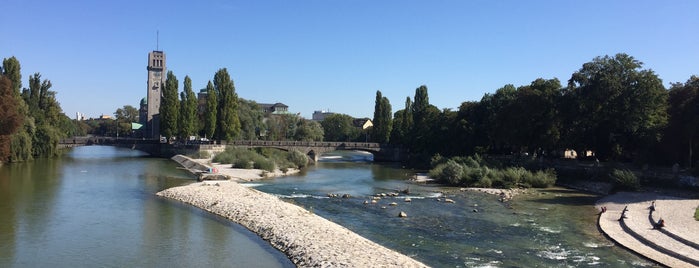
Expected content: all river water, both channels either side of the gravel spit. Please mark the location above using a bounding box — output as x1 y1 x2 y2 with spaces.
0 146 652 267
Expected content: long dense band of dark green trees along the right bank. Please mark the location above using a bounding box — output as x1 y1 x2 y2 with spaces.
370 54 699 170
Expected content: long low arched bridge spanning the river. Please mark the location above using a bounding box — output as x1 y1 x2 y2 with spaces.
59 136 407 162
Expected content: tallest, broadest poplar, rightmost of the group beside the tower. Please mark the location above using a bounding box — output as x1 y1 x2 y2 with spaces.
214 68 240 141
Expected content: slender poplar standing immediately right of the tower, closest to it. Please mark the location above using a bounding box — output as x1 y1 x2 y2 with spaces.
160 71 180 139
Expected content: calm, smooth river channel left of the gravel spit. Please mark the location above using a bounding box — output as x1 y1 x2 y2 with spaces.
0 146 293 267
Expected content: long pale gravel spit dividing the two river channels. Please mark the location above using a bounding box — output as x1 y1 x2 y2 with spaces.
157 156 427 267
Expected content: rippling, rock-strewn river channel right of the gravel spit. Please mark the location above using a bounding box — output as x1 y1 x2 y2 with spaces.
250 153 653 267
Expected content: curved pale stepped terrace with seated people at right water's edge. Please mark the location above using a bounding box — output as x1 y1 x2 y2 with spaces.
596 193 699 267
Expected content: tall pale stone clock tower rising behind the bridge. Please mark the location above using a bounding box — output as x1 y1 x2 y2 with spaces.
144 50 166 139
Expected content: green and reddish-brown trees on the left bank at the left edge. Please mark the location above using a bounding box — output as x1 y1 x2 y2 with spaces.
0 57 75 162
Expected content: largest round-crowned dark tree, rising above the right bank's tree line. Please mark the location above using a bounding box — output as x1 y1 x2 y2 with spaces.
565 54 667 159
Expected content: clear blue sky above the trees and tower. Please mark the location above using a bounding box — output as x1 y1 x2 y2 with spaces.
0 0 699 118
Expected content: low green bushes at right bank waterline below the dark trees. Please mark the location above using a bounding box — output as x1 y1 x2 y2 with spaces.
429 155 556 188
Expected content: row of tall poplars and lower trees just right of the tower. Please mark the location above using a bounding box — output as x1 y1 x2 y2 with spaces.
154 68 324 141
